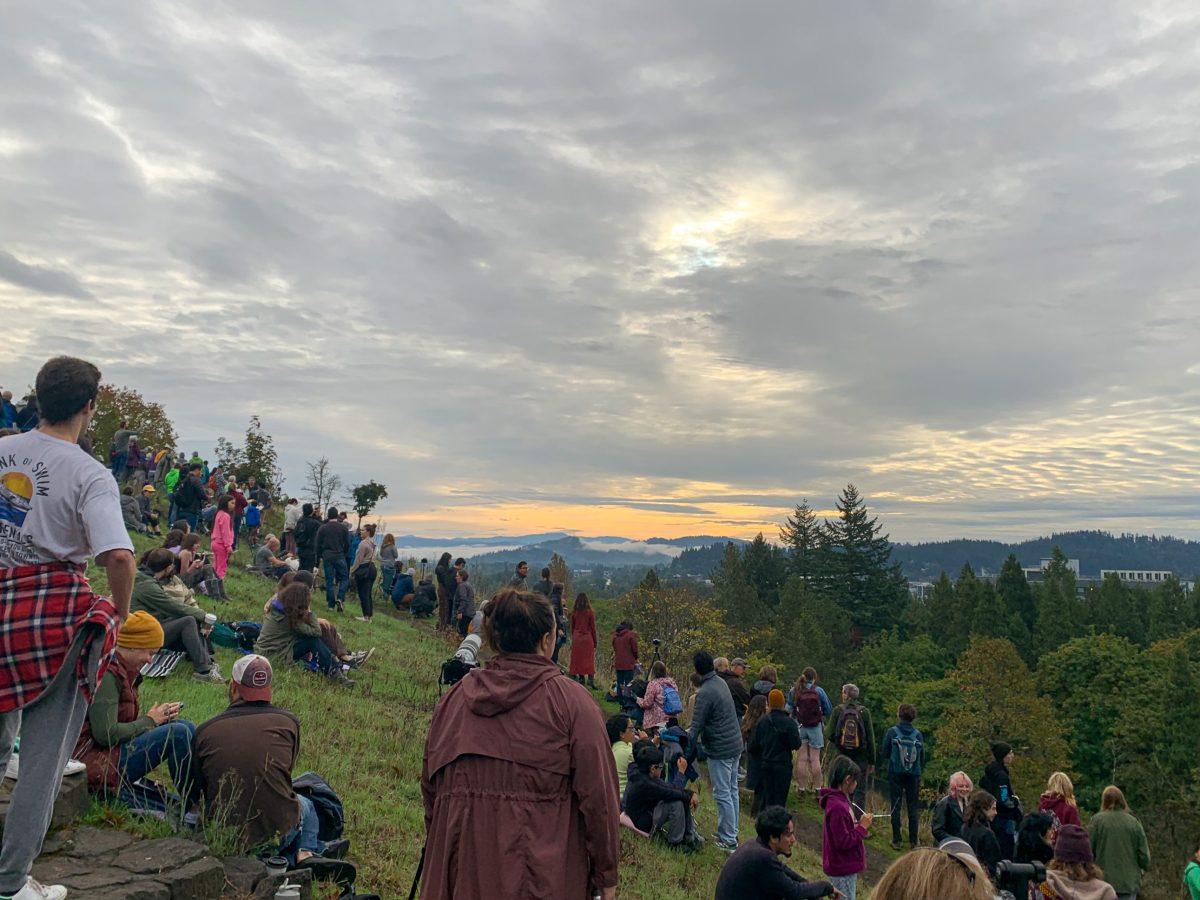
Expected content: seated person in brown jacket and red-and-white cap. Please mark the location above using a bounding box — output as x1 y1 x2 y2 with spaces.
192 654 354 883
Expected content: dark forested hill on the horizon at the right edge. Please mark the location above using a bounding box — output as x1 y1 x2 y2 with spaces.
892 532 1200 581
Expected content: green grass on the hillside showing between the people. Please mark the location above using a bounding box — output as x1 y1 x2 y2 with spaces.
89 535 864 900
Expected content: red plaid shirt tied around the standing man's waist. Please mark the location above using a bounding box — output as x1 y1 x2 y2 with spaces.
0 563 120 713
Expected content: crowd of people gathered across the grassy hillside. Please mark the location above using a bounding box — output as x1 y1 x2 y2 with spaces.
0 358 1200 900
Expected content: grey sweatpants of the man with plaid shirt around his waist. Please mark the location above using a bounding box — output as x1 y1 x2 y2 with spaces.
0 630 100 894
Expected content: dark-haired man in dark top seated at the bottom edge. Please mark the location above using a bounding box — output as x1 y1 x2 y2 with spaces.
715 806 841 900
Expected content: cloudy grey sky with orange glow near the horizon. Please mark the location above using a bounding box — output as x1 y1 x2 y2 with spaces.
0 0 1200 541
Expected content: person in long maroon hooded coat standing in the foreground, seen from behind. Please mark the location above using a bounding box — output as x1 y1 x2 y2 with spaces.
421 590 620 900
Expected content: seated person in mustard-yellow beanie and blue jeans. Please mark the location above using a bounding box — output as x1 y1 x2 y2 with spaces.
73 612 196 806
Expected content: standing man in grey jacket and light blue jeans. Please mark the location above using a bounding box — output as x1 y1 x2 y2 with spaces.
688 650 744 853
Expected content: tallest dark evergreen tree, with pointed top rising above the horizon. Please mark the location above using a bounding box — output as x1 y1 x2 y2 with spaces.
818 485 908 634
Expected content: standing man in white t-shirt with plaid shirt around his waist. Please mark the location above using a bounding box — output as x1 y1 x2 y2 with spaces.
0 356 134 900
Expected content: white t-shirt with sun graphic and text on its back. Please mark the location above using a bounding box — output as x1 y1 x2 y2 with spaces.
0 431 133 569
